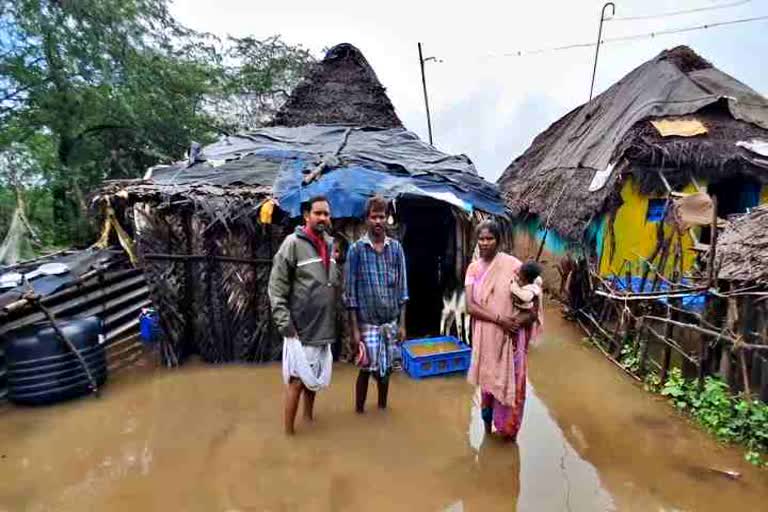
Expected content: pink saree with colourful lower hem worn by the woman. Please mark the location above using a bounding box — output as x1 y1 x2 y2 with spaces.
465 252 536 439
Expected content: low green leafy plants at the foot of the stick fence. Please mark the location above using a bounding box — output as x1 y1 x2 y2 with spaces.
661 368 768 465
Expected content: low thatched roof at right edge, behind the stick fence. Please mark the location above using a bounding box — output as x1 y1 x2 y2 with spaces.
717 205 768 285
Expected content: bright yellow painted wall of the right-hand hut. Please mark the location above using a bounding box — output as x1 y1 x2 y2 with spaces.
600 177 706 275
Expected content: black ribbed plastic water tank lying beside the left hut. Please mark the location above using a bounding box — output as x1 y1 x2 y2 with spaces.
5 316 107 405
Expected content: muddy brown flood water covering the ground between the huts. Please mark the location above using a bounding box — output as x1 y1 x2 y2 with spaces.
0 310 768 512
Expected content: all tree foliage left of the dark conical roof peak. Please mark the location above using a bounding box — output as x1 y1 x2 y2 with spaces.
0 0 312 252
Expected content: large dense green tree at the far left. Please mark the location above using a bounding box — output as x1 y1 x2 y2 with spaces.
0 0 222 243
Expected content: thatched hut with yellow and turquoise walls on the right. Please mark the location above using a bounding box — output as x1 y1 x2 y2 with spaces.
499 46 768 296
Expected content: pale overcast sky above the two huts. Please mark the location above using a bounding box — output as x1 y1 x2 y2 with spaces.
171 0 768 181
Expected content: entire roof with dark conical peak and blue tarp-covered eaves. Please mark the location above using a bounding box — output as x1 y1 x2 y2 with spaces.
96 44 506 217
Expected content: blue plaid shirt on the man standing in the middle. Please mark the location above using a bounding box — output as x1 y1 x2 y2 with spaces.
344 234 408 325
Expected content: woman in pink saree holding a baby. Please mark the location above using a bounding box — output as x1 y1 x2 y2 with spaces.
465 221 540 441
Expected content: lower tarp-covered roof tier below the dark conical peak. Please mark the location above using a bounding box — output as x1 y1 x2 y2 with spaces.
101 125 505 217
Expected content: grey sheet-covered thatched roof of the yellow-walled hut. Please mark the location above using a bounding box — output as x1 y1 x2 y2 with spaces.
499 46 768 240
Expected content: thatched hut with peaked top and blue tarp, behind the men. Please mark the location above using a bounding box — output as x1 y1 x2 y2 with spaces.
94 44 505 362
